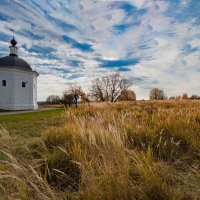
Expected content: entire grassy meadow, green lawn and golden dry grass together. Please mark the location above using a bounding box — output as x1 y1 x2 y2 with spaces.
0 100 200 200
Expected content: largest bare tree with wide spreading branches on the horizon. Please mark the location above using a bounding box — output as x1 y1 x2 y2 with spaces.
91 74 131 102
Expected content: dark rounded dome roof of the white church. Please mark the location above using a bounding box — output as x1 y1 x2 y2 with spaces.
0 56 33 72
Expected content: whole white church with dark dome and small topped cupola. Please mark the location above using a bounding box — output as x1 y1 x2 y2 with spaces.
0 37 39 110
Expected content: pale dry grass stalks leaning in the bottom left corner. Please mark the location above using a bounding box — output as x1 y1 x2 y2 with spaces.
0 127 59 200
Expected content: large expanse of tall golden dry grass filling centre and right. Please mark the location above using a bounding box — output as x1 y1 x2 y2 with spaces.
38 102 200 200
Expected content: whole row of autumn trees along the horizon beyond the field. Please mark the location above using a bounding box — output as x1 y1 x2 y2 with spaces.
46 74 200 106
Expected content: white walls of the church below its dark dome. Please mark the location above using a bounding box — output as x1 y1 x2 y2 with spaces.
0 67 38 110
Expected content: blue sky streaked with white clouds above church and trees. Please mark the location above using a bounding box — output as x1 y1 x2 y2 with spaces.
0 0 200 101
